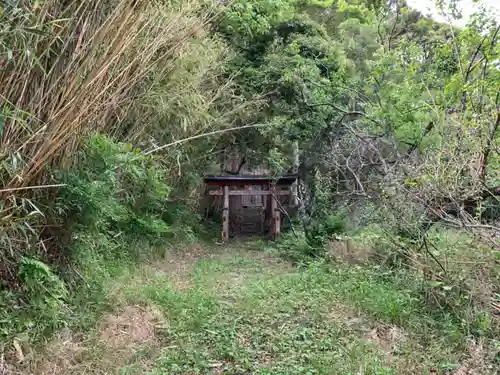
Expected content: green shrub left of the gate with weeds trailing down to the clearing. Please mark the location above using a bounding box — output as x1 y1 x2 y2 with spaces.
51 135 205 332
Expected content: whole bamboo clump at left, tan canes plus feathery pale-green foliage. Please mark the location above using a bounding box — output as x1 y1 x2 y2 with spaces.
0 0 245 256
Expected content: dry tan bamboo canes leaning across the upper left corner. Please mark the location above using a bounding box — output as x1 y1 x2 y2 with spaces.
0 0 211 188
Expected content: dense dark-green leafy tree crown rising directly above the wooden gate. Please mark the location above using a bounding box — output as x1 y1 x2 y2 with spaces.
219 1 345 172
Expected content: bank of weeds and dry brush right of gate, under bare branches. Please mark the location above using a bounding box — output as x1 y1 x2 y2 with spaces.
276 226 500 334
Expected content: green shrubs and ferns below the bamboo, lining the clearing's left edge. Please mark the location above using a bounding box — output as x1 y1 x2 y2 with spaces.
0 135 207 346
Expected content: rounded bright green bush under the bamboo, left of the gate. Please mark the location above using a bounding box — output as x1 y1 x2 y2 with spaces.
58 136 169 244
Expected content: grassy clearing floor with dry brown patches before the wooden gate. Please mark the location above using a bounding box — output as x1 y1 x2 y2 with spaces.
9 243 494 375
